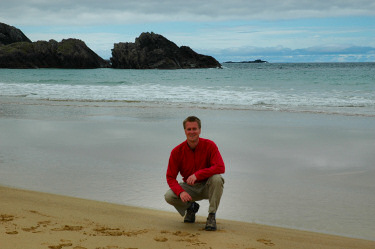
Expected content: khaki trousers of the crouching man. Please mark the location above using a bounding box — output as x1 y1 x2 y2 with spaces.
164 175 224 216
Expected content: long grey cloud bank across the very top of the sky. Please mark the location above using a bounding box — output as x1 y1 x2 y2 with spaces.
0 0 375 25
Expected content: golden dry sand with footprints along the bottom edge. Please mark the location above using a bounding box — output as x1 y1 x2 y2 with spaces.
0 187 375 249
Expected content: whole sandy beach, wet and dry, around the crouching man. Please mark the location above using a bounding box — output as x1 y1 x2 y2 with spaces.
0 98 375 245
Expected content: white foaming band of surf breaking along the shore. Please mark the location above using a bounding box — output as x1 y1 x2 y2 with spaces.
0 84 375 108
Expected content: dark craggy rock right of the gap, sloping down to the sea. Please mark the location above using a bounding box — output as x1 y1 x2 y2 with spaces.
111 33 221 69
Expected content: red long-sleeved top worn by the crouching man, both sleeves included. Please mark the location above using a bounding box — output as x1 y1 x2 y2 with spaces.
167 138 225 196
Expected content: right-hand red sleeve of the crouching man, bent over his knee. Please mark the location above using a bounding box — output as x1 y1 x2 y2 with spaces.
195 142 225 181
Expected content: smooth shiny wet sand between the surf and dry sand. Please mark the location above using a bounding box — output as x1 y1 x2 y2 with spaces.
0 98 375 241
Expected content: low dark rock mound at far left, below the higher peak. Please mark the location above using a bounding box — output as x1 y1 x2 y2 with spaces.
0 39 109 68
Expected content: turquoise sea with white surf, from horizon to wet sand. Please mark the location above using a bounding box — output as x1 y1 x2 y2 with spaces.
0 63 375 116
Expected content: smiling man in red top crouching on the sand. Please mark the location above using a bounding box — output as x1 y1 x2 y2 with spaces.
165 116 225 231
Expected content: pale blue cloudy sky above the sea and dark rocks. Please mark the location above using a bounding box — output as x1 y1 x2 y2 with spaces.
0 0 375 62
